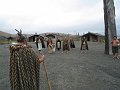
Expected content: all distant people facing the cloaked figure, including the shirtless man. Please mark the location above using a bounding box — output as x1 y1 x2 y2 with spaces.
36 36 120 59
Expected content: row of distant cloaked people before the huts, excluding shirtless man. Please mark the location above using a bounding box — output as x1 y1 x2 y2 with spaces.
36 36 88 53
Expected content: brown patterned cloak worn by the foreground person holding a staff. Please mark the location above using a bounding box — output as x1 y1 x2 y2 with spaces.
10 44 40 90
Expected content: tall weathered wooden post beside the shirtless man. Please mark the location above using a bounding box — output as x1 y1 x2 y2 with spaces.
103 0 117 54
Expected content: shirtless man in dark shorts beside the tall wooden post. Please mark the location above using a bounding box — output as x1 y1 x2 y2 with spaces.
111 36 120 59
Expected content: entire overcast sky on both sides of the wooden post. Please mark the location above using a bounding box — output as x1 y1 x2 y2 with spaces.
0 0 120 34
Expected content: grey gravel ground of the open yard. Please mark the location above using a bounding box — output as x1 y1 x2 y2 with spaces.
0 42 120 90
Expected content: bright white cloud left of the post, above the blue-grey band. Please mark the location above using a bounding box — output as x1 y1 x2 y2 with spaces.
0 0 114 32
